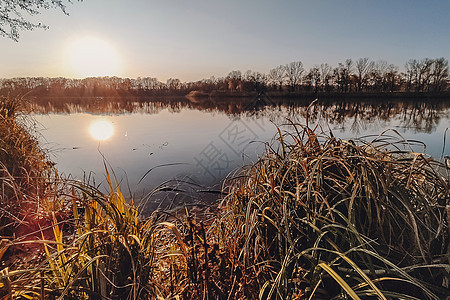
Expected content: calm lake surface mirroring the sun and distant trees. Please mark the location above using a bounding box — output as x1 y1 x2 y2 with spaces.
29 95 450 212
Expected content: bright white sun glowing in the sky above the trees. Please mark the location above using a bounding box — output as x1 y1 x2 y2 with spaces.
66 37 120 78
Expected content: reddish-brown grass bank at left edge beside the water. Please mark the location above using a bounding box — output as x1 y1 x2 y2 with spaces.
0 97 57 235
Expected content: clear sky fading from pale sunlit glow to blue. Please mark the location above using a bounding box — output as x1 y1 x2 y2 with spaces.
0 0 450 81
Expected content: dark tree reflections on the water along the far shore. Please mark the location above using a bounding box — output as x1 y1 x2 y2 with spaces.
30 97 450 133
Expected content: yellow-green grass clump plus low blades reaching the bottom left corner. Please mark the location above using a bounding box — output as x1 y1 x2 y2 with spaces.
1 170 174 299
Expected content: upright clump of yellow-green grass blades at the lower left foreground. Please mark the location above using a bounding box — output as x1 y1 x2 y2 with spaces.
38 170 164 299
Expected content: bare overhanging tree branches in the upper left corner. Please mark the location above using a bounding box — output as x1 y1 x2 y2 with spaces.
0 0 72 42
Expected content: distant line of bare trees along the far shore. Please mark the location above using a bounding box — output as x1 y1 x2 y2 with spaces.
0 58 450 97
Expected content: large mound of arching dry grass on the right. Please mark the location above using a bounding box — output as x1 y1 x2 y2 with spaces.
217 124 450 299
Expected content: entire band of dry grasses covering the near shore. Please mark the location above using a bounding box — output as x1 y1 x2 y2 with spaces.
0 98 450 299
